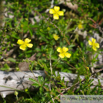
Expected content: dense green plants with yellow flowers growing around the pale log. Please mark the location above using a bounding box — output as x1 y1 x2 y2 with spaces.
0 0 103 103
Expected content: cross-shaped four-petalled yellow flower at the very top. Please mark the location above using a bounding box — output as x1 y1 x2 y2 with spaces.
49 6 64 20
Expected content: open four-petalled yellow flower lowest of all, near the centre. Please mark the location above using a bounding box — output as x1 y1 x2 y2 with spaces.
57 47 71 58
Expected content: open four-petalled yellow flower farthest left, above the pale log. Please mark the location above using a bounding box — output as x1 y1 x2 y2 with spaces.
17 38 33 50
